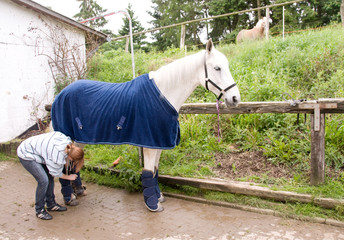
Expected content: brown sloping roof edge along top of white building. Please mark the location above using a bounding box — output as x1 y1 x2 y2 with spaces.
11 0 107 41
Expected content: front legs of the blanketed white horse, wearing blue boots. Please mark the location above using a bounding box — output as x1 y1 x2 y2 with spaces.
141 148 164 212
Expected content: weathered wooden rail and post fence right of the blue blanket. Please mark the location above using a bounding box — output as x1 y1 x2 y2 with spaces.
179 98 344 185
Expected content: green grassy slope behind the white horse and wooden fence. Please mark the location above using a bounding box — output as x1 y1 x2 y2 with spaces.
83 26 344 221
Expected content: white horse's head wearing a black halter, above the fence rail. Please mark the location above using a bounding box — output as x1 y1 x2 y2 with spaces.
201 39 240 106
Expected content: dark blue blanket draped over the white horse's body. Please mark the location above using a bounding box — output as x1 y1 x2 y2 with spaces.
51 74 180 149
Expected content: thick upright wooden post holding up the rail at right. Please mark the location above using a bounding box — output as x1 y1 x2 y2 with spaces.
311 113 325 185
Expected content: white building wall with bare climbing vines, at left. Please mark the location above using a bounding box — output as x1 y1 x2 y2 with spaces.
0 0 86 142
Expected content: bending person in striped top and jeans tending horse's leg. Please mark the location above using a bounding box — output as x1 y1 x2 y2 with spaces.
17 131 84 220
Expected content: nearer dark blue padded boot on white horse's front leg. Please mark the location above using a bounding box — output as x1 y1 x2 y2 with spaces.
141 169 164 212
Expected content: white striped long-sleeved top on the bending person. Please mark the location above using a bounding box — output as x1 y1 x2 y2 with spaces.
17 131 72 177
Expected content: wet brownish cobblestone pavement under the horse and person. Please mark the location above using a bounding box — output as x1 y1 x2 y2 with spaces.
0 161 344 240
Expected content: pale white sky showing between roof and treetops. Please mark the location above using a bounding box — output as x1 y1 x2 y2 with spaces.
33 0 152 34
